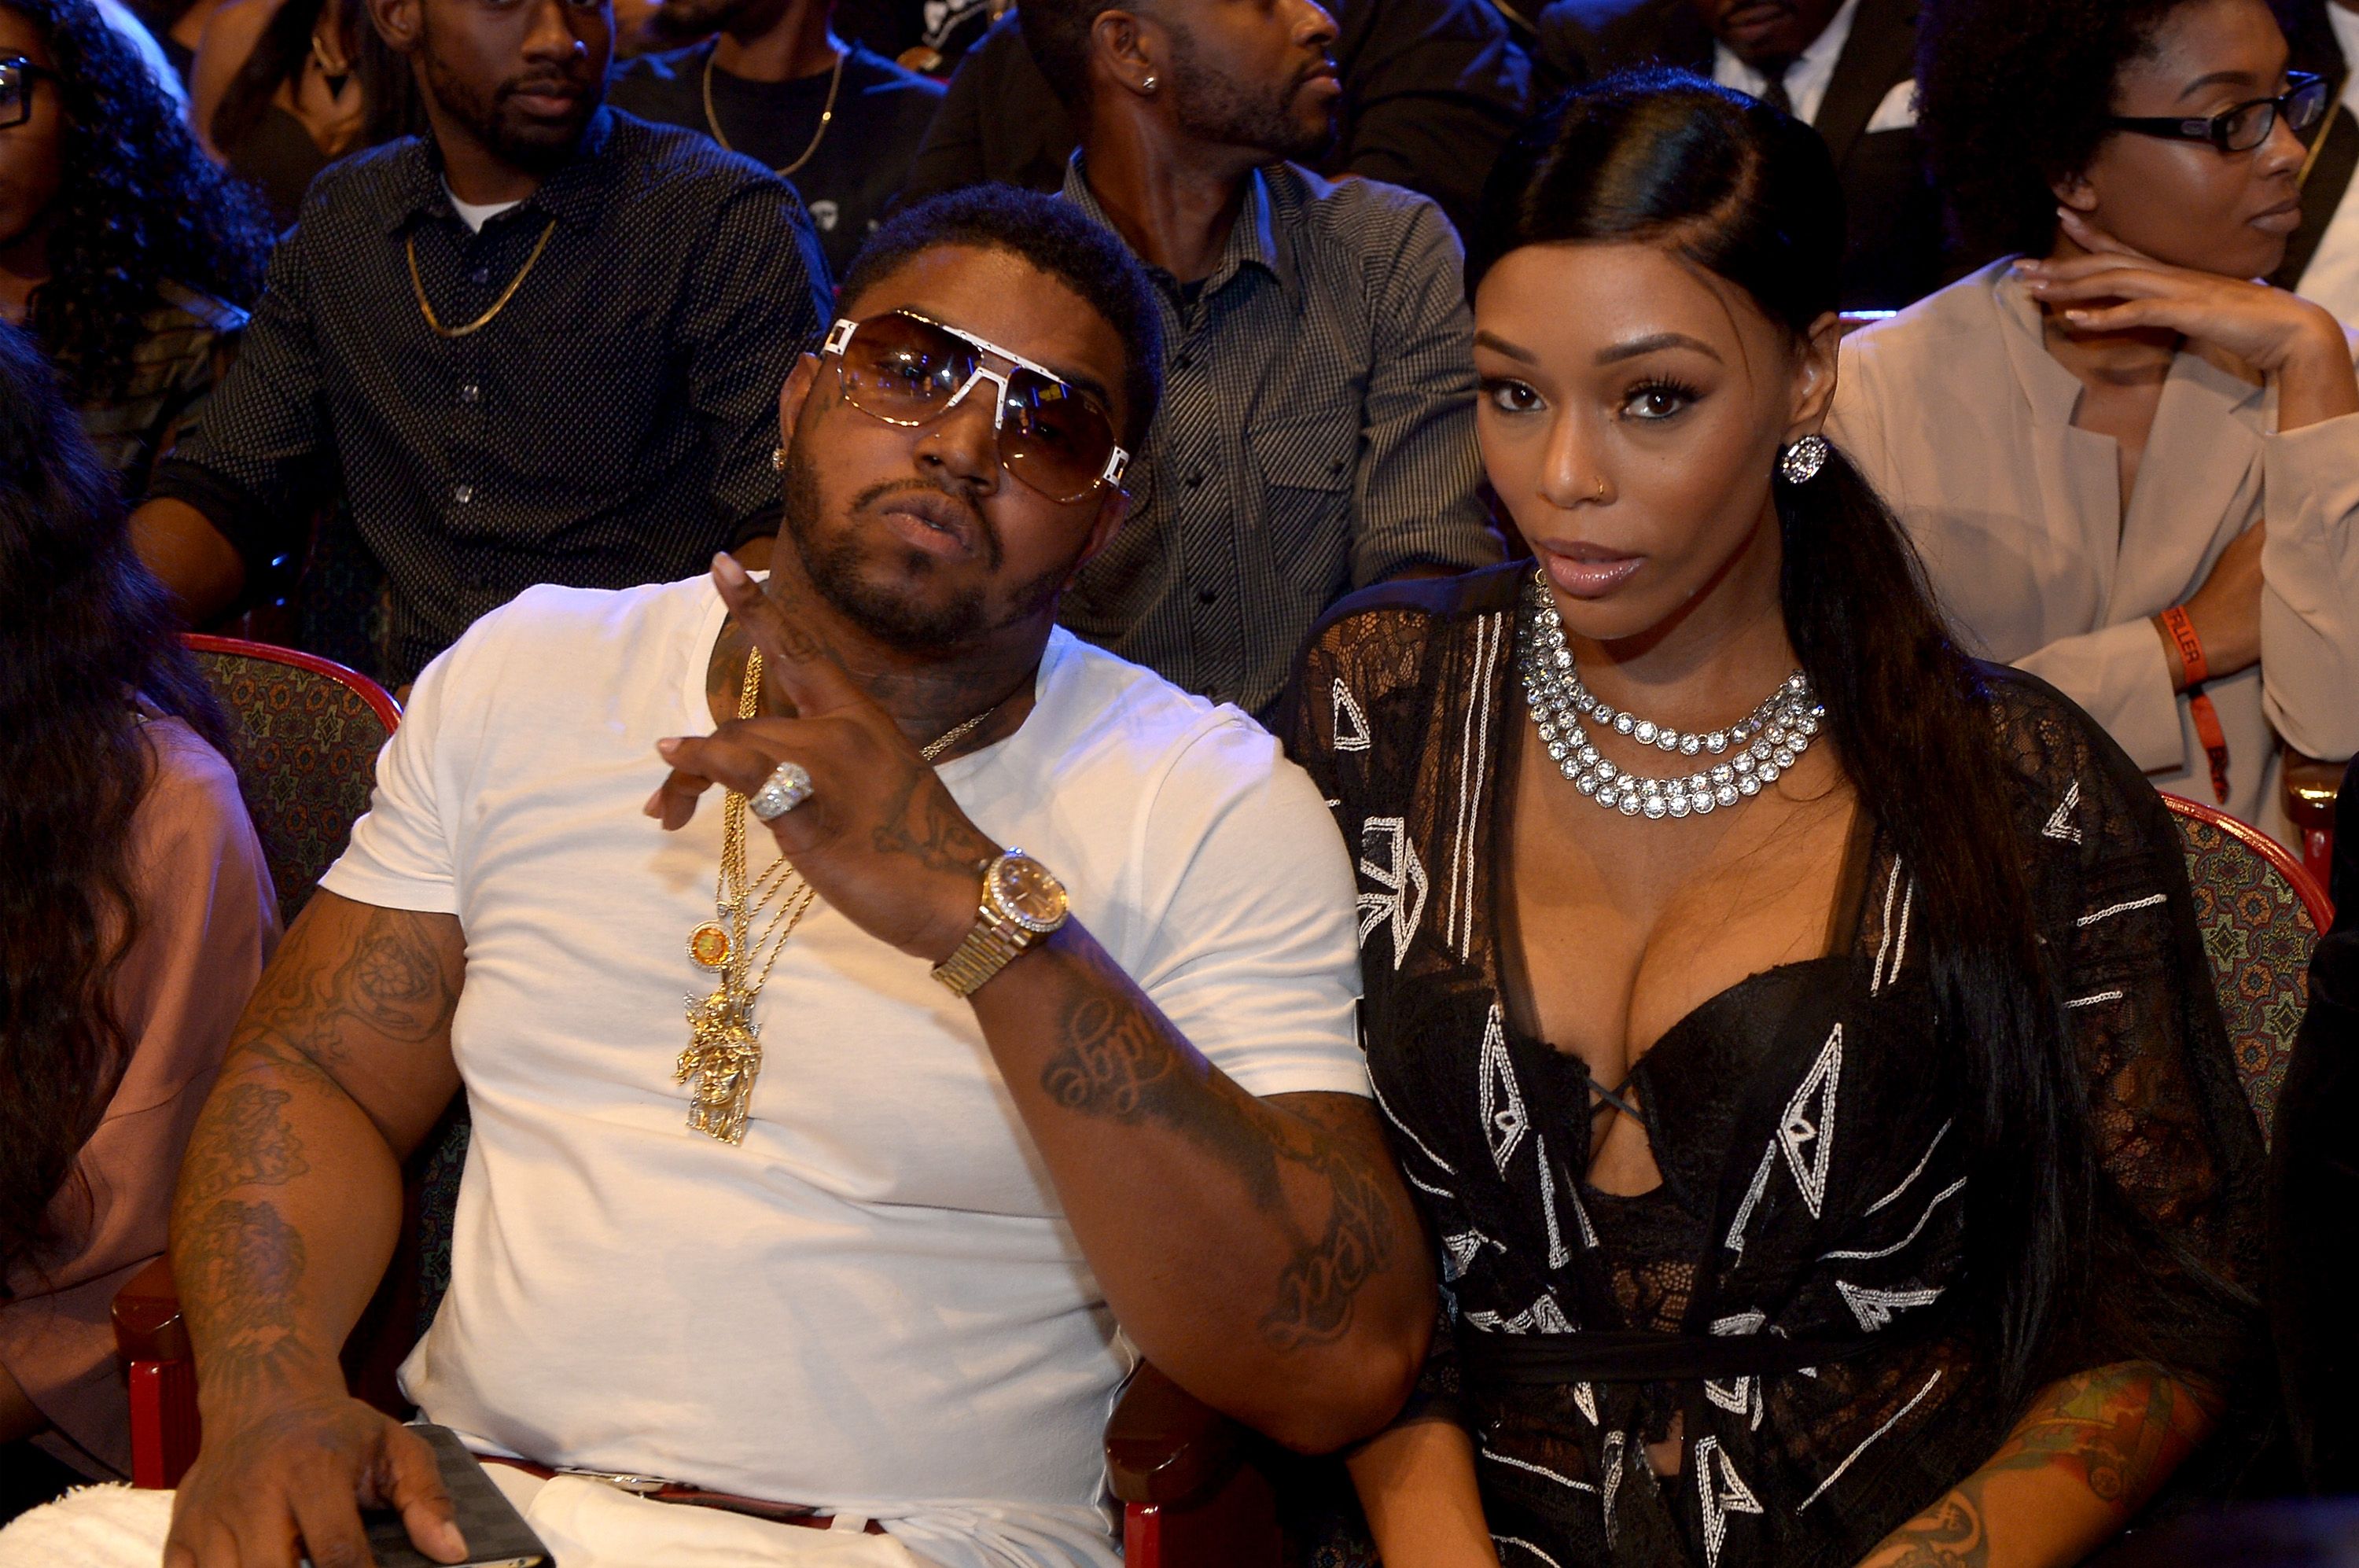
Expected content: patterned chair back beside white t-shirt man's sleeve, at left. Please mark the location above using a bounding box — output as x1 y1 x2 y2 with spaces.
184 635 401 924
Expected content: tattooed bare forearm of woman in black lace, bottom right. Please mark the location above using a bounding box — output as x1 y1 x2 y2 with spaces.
1861 1363 2213 1568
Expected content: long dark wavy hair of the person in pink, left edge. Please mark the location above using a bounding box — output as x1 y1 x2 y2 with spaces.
0 326 229 1275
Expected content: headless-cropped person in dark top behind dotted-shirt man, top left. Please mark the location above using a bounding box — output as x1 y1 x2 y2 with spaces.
191 0 425 229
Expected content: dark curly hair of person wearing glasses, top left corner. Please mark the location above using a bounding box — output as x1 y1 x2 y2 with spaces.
0 0 271 403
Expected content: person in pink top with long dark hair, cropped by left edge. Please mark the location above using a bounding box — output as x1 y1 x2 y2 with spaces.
0 328 278 1509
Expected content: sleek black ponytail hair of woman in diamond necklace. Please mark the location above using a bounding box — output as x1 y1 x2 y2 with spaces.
1467 71 2092 1410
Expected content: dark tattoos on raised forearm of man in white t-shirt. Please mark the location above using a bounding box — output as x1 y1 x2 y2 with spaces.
1040 943 1399 1351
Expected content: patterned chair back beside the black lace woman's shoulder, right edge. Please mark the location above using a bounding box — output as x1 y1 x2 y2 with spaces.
2163 794 2333 1139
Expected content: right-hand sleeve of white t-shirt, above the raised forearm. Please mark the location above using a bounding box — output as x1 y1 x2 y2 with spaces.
1132 720 1368 1096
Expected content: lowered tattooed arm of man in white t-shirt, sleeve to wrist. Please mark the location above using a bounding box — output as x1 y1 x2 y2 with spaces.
172 891 462 1419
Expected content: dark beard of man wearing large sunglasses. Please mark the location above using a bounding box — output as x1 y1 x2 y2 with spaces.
778 444 1071 653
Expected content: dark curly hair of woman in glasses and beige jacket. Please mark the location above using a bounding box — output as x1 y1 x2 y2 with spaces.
1918 0 2189 264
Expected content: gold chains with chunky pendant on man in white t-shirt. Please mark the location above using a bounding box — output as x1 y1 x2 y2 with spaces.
672 649 1005 1143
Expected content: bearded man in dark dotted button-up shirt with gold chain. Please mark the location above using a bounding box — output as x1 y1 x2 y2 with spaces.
132 0 828 686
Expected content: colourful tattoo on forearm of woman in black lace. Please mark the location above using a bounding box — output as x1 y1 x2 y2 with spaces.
1868 1363 2210 1568
